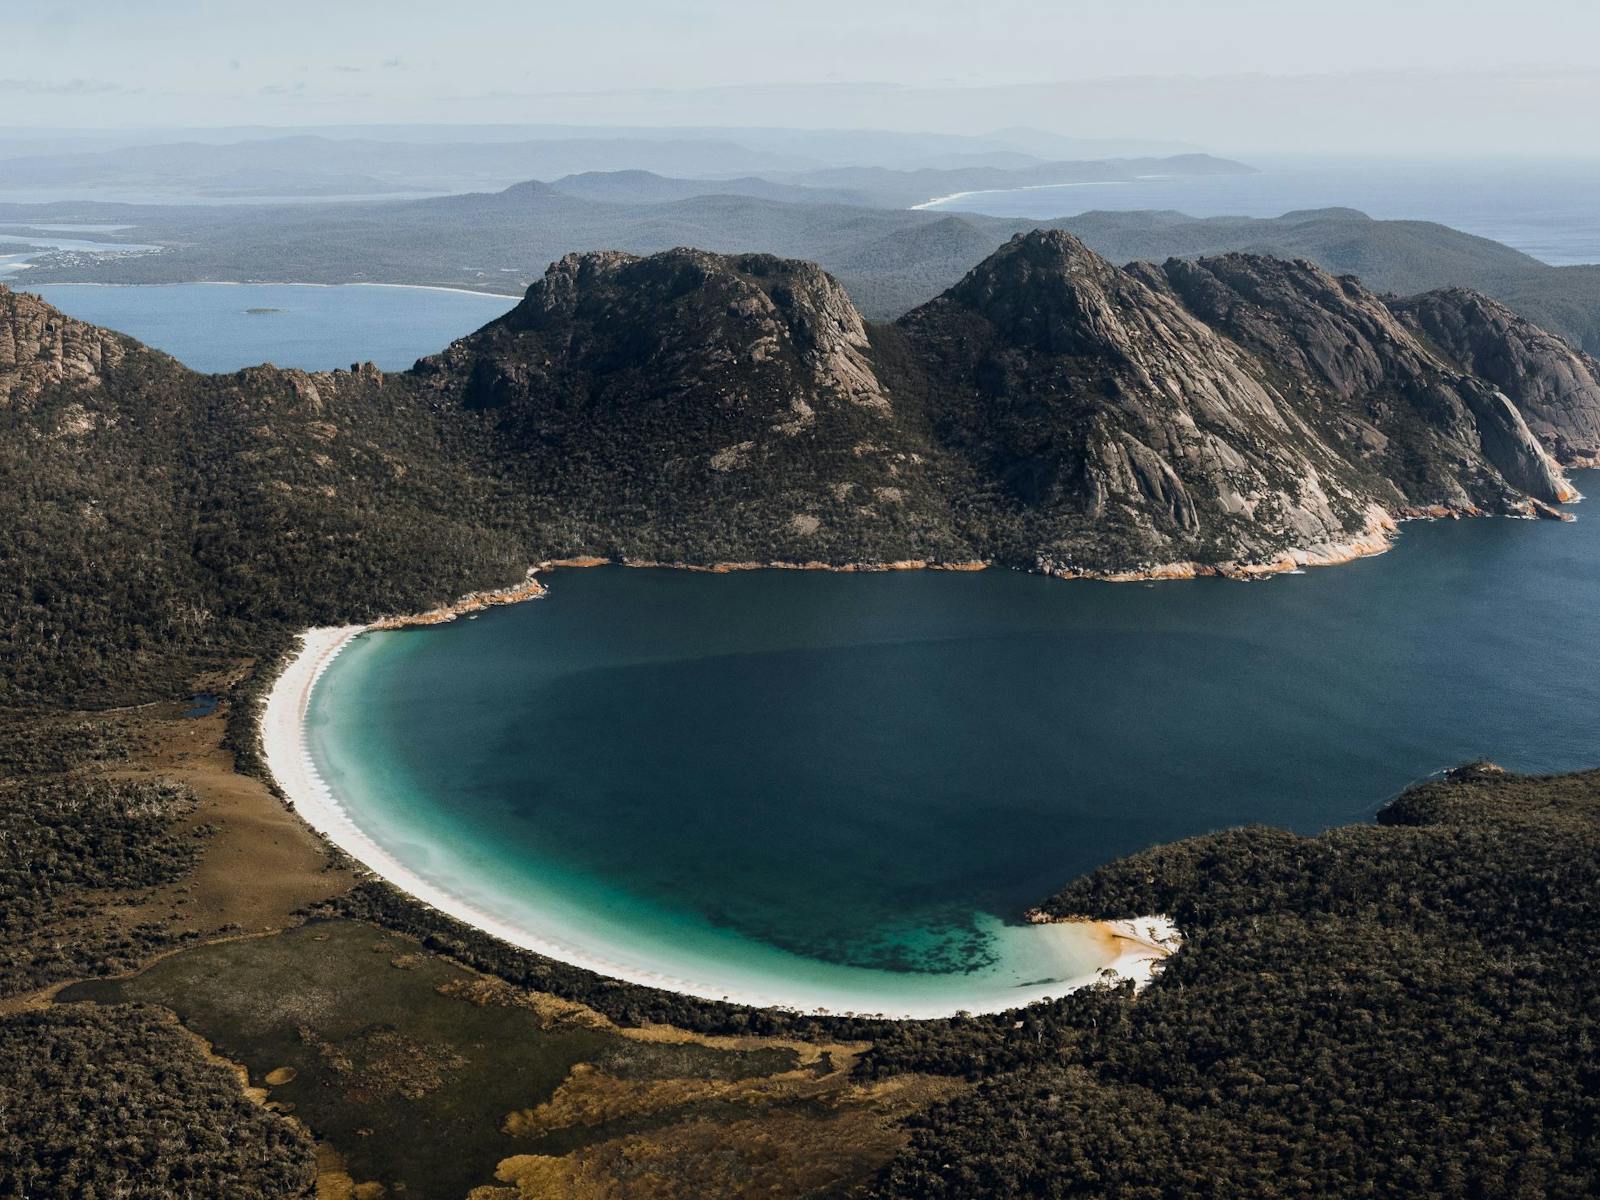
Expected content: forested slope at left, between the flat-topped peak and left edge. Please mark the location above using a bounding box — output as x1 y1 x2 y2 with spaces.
0 288 526 706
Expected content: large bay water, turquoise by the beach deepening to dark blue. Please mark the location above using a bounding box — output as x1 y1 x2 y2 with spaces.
309 474 1600 1010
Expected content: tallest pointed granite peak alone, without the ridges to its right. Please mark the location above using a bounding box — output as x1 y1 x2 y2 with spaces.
899 230 1390 573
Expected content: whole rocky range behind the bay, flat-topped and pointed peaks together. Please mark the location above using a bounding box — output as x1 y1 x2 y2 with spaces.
414 230 1600 578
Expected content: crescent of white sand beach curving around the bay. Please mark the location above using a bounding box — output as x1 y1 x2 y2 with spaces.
261 626 1182 1019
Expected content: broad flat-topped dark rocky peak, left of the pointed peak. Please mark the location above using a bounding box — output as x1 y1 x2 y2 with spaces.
413 250 971 560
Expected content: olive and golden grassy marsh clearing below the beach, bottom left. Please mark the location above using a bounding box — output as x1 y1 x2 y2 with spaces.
61 920 957 1200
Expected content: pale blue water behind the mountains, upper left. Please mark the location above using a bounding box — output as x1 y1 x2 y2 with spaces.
15 281 517 371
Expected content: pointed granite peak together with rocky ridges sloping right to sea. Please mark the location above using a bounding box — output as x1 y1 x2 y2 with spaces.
899 232 1573 571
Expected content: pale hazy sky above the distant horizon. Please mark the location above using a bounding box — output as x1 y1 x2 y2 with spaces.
9 0 1600 154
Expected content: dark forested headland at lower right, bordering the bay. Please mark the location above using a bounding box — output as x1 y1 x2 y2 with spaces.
875 766 1600 1200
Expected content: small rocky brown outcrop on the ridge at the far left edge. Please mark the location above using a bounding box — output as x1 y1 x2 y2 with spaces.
0 285 139 408
